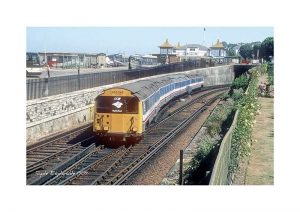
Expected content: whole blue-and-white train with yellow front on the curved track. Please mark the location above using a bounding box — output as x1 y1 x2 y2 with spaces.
93 74 204 143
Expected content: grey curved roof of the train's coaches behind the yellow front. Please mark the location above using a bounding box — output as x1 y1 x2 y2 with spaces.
120 74 199 100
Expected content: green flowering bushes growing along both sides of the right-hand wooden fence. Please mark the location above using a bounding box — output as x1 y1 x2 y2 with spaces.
184 65 271 184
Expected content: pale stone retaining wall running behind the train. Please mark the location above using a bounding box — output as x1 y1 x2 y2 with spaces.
26 65 234 144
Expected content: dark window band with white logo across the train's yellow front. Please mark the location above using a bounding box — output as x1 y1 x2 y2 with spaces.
96 96 139 114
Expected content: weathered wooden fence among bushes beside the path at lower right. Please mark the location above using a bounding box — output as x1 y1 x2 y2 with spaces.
209 111 239 185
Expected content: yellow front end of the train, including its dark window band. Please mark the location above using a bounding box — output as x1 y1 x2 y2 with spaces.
93 88 143 142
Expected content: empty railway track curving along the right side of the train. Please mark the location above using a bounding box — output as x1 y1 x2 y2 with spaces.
53 88 226 185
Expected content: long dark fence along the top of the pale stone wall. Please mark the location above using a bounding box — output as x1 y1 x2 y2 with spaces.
26 59 214 100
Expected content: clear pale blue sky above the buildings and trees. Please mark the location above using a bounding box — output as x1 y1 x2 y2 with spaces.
26 26 273 55
